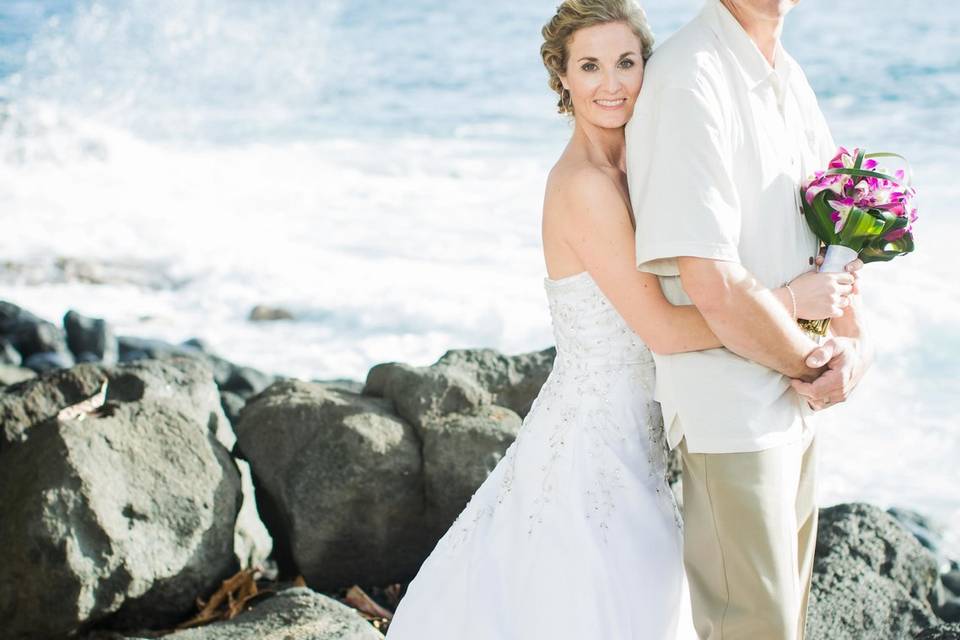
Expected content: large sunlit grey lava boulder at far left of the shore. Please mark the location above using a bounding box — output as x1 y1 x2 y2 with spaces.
0 359 242 640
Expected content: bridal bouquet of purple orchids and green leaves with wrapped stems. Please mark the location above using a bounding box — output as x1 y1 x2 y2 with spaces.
800 147 917 336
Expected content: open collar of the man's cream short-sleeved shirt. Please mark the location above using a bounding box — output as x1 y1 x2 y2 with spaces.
701 0 791 91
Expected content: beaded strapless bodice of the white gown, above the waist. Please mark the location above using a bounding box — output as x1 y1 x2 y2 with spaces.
544 271 653 365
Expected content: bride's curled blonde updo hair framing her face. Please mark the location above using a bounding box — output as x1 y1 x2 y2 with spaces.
540 0 653 115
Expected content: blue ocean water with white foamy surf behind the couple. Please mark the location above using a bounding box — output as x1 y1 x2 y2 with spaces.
0 0 960 557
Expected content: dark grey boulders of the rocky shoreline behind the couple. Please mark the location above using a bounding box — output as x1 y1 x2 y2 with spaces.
0 301 960 640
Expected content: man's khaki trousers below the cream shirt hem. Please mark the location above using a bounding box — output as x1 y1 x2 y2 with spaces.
680 432 817 640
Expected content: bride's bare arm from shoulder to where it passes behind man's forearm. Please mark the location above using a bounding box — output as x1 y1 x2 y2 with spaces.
558 168 723 354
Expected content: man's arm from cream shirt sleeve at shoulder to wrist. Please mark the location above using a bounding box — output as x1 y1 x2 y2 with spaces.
627 85 825 380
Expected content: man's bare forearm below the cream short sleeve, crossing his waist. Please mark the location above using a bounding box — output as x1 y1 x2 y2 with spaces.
677 257 826 381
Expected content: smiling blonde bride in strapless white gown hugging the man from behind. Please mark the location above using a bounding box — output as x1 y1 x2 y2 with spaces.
387 0 862 640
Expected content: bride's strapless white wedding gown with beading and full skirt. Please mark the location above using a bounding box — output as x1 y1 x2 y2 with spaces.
387 272 696 640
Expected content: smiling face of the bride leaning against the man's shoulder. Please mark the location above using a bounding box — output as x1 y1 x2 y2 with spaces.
560 22 643 128
